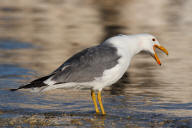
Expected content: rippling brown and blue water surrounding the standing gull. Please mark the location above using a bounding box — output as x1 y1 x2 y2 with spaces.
0 0 192 128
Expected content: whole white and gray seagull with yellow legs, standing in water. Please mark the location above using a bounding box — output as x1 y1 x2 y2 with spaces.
10 33 168 115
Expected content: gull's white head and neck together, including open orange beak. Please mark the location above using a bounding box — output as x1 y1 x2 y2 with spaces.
104 34 168 65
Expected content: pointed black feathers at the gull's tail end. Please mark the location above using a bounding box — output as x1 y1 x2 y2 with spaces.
10 75 52 91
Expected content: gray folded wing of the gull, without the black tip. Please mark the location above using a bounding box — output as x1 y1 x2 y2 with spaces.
52 45 120 84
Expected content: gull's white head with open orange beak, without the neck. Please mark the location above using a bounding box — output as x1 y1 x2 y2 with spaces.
137 34 168 65
